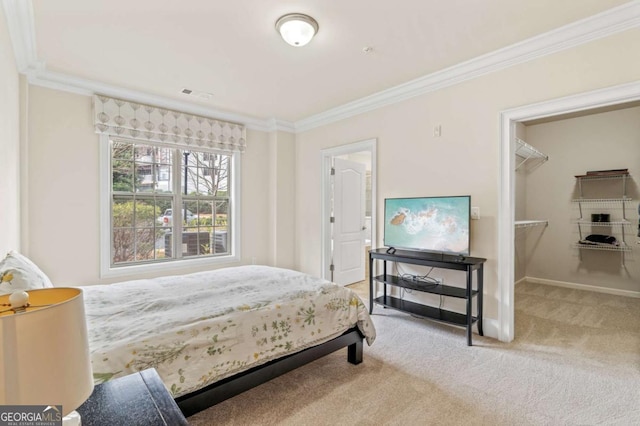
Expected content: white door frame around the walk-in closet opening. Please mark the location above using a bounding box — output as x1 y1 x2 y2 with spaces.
498 80 640 342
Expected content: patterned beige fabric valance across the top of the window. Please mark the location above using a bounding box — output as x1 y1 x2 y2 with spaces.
93 95 247 152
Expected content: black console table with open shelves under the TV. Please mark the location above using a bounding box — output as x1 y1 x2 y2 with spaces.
369 248 486 346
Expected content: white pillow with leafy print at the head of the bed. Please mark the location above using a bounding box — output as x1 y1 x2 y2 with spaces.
0 250 53 294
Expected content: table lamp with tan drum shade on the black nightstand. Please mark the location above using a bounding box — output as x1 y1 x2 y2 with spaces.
0 287 93 425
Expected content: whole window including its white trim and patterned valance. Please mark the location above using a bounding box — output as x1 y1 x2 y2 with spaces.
93 94 247 277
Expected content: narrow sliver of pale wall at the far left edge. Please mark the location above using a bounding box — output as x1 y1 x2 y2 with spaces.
0 7 20 255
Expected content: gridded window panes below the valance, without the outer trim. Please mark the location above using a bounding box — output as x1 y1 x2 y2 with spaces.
103 137 239 272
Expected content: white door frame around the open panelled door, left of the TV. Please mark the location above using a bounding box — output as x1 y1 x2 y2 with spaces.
320 138 378 280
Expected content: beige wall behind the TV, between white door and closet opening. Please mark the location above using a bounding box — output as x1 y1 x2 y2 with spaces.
296 29 640 319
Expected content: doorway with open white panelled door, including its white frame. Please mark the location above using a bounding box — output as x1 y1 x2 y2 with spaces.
321 139 377 285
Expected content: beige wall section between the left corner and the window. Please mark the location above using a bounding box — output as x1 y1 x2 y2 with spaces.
22 87 100 285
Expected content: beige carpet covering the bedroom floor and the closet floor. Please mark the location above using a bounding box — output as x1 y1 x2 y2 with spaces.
189 283 640 426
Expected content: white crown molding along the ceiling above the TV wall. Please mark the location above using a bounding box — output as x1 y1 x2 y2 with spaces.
295 0 640 132
